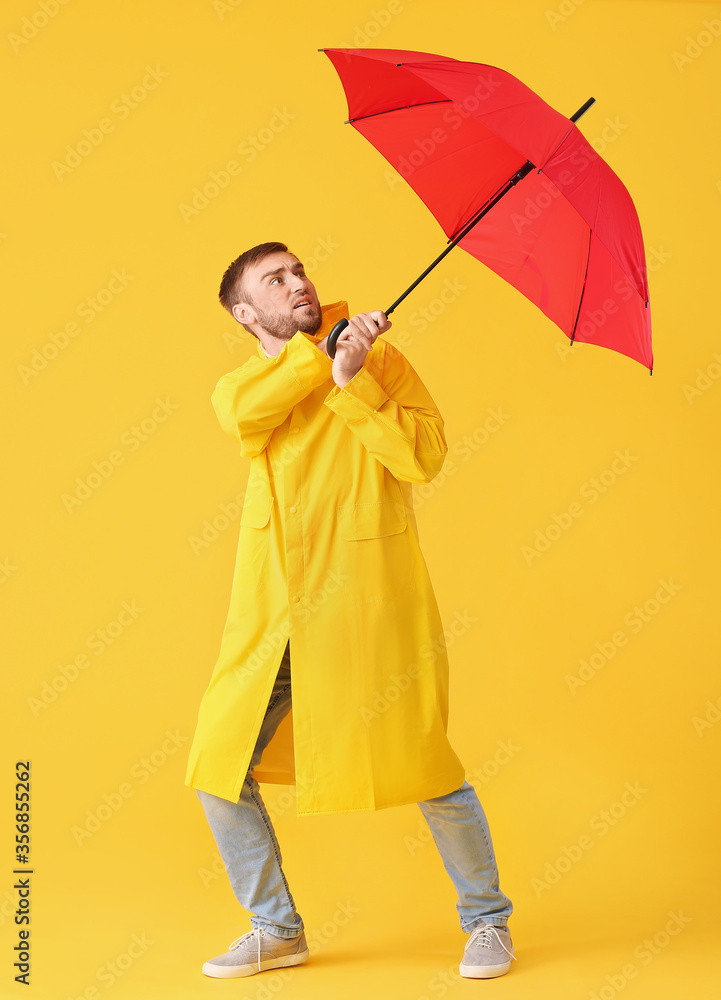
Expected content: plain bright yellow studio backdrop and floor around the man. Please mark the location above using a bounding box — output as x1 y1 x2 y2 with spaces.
0 0 721 1000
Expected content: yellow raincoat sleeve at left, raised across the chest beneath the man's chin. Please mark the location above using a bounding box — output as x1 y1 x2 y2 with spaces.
211 330 333 458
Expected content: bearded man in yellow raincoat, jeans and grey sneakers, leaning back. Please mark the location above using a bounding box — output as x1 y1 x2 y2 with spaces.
186 243 515 978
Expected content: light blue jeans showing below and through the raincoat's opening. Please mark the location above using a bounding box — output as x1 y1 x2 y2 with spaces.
196 642 513 938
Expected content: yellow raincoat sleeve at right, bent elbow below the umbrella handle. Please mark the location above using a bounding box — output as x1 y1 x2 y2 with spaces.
324 342 448 483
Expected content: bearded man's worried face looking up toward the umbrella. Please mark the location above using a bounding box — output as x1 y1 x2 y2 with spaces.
236 251 322 340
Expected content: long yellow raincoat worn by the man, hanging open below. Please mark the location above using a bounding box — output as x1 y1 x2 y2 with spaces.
185 302 465 815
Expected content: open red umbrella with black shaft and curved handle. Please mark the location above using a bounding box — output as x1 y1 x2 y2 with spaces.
320 49 653 372
